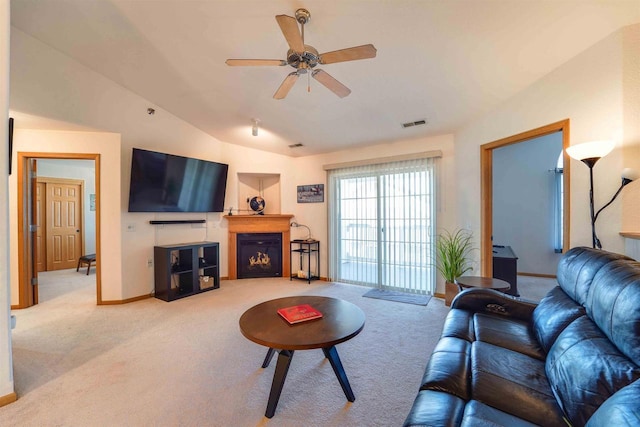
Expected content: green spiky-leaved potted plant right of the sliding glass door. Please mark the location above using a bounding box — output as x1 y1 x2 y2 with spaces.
436 230 473 306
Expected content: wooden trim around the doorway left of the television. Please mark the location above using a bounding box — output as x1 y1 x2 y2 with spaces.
16 152 102 309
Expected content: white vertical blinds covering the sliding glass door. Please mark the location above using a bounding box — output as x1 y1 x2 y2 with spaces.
328 157 437 294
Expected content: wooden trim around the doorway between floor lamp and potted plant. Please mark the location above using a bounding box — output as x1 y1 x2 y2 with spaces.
480 119 571 277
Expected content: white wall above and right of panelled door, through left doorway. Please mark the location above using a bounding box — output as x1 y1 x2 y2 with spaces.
38 159 96 254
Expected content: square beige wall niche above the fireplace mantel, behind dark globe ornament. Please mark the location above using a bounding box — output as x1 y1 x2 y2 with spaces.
238 173 281 215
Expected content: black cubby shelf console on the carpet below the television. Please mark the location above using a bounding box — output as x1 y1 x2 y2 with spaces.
153 242 220 301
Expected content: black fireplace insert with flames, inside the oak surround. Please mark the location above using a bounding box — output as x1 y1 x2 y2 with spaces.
236 233 282 279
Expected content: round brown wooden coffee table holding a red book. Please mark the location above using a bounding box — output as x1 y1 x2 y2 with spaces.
240 296 365 418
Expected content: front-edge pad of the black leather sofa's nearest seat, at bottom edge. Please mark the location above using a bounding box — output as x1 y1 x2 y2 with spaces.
403 390 466 427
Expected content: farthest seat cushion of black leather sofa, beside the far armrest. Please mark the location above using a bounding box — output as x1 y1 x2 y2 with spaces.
473 313 546 360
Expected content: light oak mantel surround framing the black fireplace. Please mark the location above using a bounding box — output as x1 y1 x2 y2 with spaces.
224 214 293 280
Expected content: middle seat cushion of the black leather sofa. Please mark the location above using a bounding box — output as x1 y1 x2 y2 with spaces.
471 341 566 427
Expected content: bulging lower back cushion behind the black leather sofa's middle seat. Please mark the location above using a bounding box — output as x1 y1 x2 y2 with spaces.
546 316 640 425
